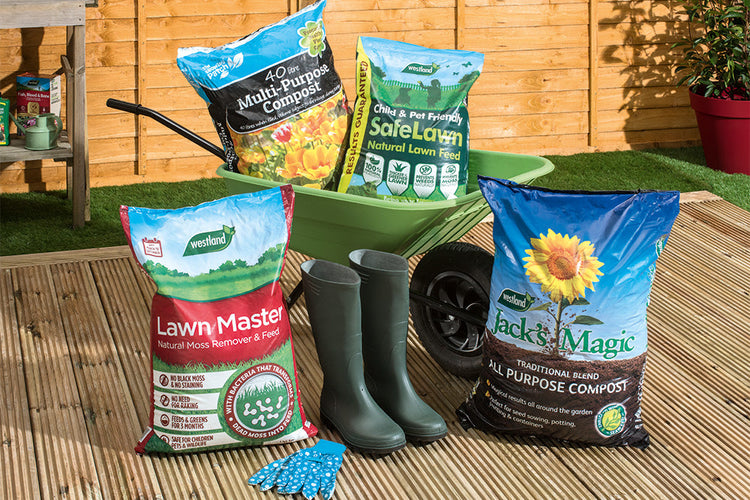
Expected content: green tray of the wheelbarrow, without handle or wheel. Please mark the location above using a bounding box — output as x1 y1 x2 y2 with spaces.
216 149 554 264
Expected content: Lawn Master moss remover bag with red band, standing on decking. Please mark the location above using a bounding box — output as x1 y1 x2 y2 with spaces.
120 185 317 453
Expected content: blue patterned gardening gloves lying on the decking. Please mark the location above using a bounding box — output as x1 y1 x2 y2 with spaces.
247 439 346 500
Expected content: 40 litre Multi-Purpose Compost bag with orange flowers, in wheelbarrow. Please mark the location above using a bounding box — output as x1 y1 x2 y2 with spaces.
177 0 348 189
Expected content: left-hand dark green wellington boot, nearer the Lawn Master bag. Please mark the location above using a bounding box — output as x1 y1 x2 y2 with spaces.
300 260 406 454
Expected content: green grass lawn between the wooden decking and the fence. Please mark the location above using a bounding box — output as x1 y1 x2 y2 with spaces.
0 148 750 255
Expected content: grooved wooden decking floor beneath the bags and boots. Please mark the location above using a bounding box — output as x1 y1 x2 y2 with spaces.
0 194 750 500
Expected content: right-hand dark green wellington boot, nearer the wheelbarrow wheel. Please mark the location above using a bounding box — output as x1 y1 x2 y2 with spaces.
349 250 447 443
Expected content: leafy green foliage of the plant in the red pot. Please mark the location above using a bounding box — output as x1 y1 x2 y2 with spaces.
674 0 750 100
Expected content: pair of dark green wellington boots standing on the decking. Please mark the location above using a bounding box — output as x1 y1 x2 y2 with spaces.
301 250 447 454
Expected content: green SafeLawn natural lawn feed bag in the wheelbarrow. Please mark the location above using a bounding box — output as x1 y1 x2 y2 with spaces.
338 37 484 201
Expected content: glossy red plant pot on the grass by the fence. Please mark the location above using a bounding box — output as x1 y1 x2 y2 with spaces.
690 91 750 175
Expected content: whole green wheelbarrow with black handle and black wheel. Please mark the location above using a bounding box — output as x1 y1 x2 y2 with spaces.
107 99 554 378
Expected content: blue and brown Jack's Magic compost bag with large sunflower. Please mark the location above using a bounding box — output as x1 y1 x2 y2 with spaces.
457 177 679 448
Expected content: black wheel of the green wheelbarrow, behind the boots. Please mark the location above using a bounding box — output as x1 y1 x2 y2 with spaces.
410 242 493 378
